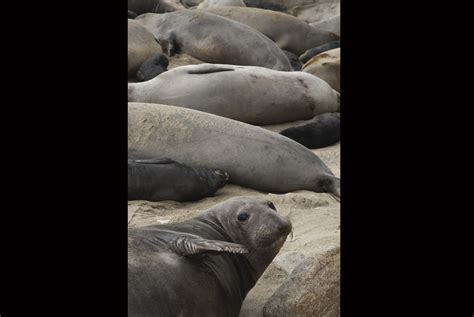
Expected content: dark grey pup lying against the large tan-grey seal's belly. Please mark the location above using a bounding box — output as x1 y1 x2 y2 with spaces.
128 158 229 202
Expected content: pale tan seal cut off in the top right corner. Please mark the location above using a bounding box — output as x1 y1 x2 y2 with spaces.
287 2 341 23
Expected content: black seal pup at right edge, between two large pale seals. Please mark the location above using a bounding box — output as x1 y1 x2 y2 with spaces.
280 112 341 149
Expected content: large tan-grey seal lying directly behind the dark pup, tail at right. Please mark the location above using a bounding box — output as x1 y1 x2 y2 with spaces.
128 103 340 197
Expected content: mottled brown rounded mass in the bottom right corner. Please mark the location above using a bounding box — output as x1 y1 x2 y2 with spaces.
263 247 340 317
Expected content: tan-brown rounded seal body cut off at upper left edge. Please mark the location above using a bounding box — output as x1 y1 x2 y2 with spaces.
128 19 161 77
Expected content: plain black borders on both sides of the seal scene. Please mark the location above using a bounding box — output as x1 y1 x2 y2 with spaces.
0 0 474 317
